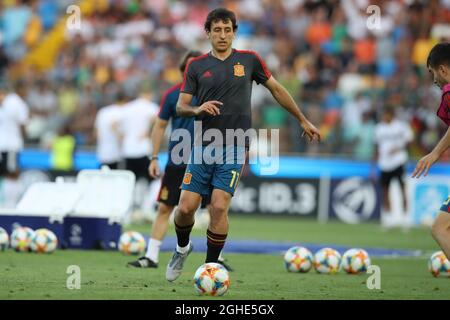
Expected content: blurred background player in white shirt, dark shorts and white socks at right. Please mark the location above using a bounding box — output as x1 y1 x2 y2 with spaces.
375 107 414 227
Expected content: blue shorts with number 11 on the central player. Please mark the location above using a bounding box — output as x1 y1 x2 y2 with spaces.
181 146 246 196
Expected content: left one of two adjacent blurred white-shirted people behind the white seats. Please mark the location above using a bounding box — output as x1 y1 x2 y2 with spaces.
95 92 127 169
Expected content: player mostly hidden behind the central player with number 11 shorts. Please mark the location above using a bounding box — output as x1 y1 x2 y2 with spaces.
128 51 231 271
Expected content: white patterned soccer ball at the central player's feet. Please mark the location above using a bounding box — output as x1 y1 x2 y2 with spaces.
194 263 230 296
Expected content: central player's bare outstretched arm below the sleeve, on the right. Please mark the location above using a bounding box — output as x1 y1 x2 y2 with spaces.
264 76 320 141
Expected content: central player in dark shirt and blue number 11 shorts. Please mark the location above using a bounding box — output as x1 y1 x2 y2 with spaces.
166 8 320 281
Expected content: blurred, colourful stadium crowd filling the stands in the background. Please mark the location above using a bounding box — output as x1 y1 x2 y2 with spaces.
0 0 450 159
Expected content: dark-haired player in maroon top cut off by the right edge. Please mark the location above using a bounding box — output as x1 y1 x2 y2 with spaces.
412 43 450 259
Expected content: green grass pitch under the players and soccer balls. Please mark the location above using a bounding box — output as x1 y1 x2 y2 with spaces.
0 215 450 300
